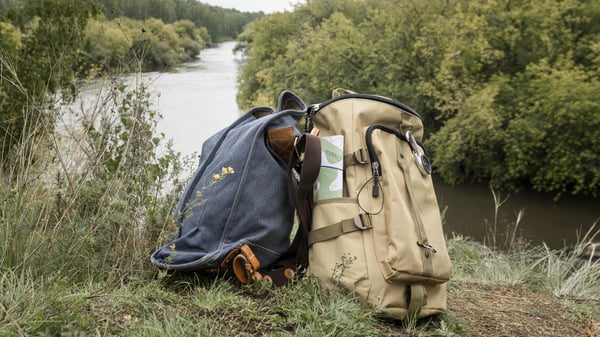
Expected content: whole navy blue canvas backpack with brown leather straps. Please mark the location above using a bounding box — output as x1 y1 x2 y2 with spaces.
151 91 321 284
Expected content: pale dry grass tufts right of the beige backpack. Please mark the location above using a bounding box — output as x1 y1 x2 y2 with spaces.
449 186 600 301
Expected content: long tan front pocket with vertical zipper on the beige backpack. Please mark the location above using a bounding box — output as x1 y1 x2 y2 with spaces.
368 127 451 284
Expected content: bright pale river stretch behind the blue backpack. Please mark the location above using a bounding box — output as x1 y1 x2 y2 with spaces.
150 42 240 155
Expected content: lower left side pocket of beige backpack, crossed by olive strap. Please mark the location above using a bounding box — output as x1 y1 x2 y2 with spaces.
309 198 369 298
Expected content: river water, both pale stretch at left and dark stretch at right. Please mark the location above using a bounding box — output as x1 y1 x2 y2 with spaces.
144 42 600 248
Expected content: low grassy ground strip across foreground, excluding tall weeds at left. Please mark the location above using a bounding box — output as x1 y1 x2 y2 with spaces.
0 232 600 337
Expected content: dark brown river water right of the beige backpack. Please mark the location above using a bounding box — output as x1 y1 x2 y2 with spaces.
434 175 600 249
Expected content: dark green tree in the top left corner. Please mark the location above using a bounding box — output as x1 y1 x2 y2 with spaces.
0 0 97 158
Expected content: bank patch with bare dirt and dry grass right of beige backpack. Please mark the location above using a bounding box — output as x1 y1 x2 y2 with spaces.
448 232 600 337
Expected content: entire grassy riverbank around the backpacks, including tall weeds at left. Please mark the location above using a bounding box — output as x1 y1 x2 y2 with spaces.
0 130 600 337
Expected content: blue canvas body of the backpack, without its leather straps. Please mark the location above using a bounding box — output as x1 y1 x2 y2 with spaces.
151 91 307 271
